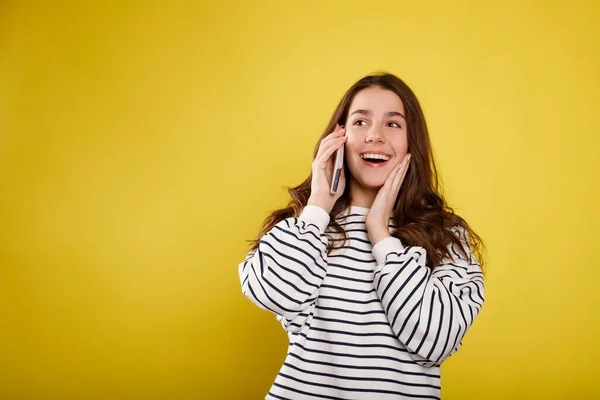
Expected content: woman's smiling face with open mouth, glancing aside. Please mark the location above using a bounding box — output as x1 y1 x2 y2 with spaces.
345 86 408 189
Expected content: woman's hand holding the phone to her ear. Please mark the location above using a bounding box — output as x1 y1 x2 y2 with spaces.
307 125 348 214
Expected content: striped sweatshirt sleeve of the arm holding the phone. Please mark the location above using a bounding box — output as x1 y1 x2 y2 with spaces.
238 205 329 327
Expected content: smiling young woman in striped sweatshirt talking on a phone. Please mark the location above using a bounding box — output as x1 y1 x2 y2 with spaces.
239 74 483 400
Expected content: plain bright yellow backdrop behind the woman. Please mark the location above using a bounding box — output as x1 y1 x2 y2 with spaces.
0 0 600 400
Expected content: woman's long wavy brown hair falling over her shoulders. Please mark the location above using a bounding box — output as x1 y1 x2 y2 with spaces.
251 72 484 269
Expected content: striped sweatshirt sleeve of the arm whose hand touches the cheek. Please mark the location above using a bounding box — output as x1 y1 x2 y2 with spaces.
373 227 484 367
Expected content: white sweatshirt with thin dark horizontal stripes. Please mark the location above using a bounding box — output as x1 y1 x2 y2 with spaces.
238 205 484 400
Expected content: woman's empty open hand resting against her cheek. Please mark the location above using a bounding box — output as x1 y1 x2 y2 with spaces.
365 154 410 246
